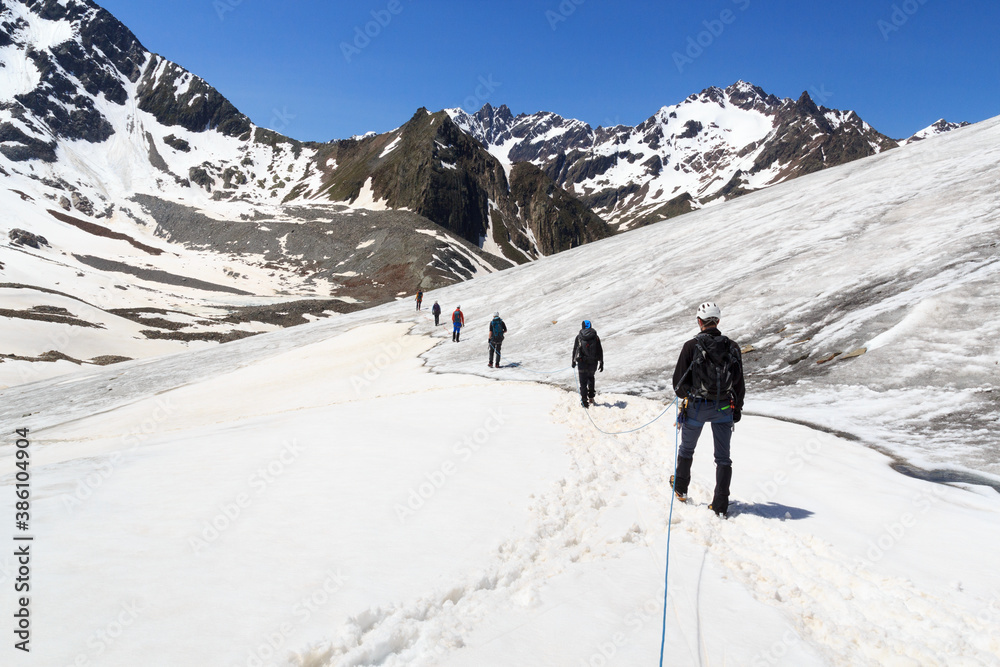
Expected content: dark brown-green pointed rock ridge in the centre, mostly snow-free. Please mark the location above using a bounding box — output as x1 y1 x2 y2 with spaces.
308 109 612 262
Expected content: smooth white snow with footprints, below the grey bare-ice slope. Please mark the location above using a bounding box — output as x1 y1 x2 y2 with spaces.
0 320 1000 666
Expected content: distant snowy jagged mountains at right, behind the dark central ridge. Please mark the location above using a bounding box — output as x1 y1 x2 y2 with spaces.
451 80 896 229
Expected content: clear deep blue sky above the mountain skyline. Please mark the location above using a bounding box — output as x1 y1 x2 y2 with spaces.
97 0 1000 141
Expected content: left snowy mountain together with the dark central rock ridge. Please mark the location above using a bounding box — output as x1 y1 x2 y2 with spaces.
0 0 612 358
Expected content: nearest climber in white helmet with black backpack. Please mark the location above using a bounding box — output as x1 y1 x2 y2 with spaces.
670 303 746 517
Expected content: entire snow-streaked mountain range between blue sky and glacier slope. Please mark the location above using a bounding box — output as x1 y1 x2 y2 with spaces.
0 0 972 380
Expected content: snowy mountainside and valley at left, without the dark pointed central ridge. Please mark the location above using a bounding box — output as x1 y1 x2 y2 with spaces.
0 0 532 374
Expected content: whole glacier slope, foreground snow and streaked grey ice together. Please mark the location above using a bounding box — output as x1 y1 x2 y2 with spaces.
0 108 1000 665
